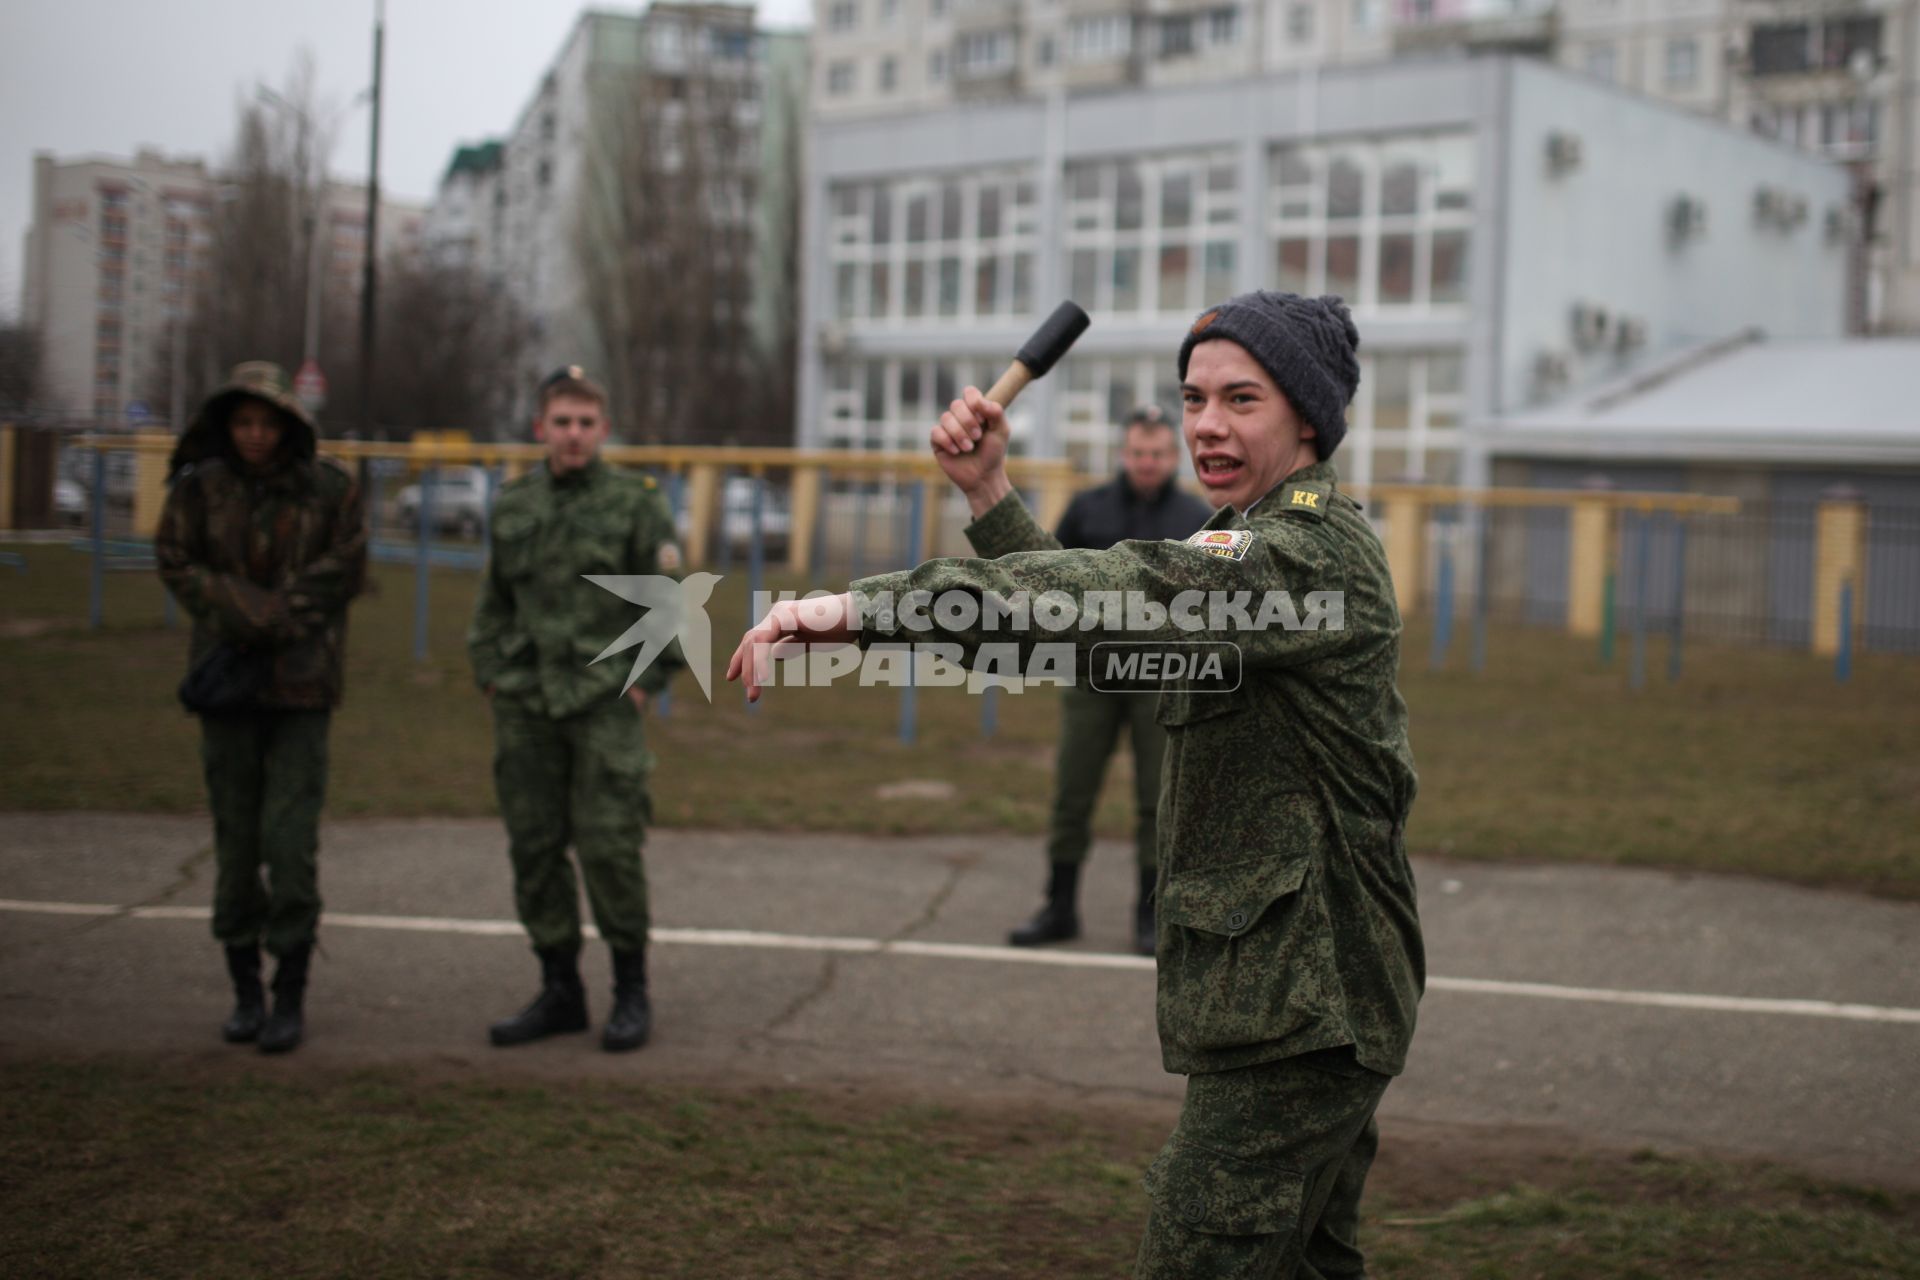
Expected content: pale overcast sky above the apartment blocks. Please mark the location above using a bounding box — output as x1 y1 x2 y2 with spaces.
0 0 810 317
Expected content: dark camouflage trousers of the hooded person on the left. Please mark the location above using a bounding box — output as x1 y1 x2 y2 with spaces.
200 712 332 956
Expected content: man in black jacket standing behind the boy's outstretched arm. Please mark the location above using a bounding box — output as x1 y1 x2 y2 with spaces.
1006 405 1213 956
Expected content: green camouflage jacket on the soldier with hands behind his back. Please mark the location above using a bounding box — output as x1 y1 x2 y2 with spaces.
467 459 682 718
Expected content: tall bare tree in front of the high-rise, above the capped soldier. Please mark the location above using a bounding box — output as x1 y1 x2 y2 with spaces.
572 69 762 443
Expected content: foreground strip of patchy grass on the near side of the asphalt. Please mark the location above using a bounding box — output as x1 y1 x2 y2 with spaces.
0 1059 1920 1280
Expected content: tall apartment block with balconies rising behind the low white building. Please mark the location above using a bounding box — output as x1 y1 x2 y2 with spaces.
812 0 1920 332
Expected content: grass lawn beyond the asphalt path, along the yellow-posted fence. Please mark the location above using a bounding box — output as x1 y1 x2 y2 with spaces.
11 547 1920 898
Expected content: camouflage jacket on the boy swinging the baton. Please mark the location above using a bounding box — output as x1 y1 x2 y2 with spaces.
854 462 1425 1075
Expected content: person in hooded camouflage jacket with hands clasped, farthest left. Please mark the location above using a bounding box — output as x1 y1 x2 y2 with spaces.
154 361 367 1054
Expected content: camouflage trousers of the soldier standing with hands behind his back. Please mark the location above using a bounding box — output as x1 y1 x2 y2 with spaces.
493 693 653 952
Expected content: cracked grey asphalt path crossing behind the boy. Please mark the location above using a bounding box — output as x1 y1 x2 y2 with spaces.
0 814 1920 1186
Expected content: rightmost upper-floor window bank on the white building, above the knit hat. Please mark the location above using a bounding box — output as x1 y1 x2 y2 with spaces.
1267 134 1473 313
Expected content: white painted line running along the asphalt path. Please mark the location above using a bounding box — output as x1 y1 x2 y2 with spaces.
0 898 1920 1025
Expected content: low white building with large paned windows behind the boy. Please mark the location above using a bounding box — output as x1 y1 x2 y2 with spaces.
799 58 1849 484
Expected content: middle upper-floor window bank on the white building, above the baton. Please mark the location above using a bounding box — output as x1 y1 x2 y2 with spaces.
1064 152 1240 315
